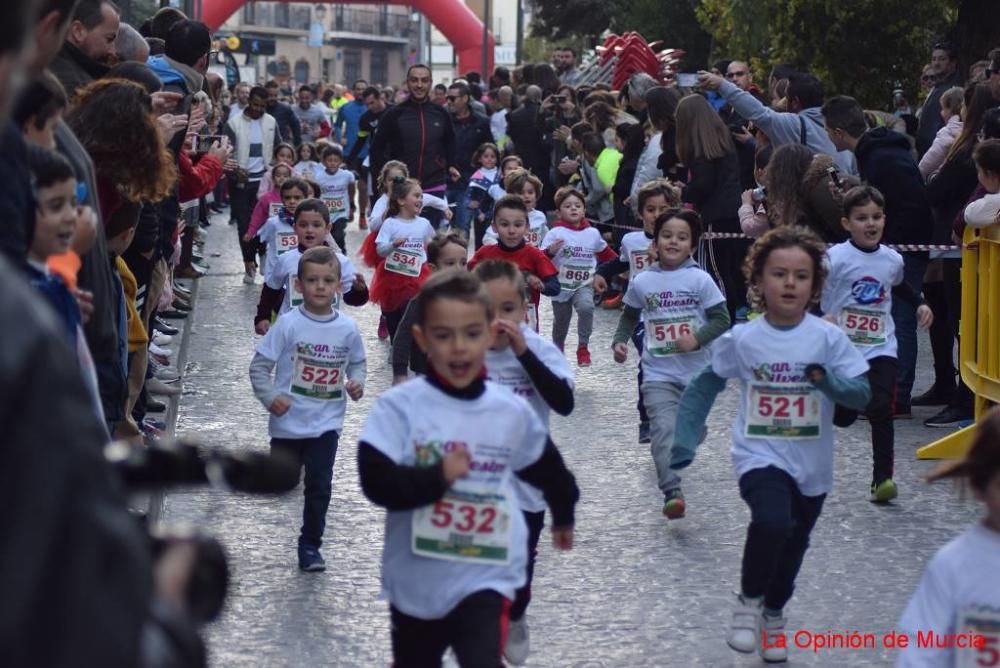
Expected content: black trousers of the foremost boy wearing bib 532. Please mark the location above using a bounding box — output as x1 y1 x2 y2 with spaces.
389 591 510 668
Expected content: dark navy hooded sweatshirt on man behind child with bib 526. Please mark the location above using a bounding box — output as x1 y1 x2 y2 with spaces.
854 128 934 244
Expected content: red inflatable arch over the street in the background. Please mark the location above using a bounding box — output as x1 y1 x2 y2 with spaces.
202 0 494 80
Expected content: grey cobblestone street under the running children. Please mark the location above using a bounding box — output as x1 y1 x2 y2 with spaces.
163 215 976 668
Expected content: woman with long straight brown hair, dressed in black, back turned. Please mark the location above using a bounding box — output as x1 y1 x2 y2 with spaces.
675 95 750 322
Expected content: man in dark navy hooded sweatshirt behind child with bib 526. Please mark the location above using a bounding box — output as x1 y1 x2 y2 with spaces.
823 95 934 417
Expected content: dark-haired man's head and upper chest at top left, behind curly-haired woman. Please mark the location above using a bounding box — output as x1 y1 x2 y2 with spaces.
51 0 121 97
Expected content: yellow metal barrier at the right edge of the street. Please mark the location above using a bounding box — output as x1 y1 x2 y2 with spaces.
917 225 1000 459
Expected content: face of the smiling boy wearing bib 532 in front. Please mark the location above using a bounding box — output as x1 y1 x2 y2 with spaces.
413 298 493 390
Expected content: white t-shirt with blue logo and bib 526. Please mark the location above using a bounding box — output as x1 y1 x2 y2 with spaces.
820 241 903 360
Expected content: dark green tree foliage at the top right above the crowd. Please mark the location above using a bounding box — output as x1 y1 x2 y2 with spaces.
696 0 954 109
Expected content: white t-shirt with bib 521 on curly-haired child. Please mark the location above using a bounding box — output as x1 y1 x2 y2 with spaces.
712 315 868 496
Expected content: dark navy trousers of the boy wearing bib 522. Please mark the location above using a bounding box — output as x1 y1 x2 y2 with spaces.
271 431 340 548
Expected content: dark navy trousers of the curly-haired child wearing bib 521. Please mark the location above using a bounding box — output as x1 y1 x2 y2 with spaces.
740 466 826 610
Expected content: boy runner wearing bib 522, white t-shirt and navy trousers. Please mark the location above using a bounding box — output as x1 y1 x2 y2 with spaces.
250 246 366 572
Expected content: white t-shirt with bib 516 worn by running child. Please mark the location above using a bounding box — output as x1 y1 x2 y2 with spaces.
624 260 726 385
